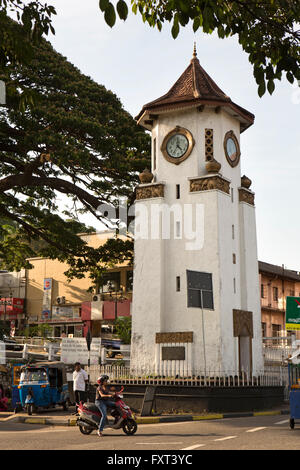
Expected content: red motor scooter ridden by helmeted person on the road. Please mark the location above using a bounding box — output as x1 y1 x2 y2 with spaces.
76 387 137 435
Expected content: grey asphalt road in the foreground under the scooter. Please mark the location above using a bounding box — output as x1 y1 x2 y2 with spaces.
0 415 300 451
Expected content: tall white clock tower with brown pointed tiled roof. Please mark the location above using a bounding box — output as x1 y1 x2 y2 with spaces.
131 48 263 376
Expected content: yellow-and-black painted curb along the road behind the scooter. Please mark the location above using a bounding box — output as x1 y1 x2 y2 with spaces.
5 410 290 427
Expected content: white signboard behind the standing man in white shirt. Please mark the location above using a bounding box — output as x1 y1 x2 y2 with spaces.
61 338 101 365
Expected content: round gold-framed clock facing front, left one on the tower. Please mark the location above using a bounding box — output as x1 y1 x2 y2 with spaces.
161 126 195 165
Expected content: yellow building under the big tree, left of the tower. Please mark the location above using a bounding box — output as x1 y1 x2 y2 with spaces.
26 231 132 336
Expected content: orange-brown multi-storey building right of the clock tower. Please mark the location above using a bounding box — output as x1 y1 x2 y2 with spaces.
259 261 300 338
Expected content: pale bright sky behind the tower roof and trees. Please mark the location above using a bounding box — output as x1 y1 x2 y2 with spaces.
48 0 300 271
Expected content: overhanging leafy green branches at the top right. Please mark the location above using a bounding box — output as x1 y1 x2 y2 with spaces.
99 0 300 96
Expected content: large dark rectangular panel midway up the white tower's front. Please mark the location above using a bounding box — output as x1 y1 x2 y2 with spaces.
186 270 214 310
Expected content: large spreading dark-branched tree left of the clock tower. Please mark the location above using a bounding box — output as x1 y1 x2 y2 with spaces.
0 17 150 276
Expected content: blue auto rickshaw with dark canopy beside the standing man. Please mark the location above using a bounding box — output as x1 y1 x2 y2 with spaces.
18 362 69 415
